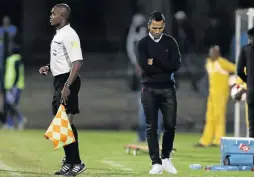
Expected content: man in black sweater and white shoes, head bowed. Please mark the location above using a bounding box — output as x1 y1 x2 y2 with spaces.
137 12 181 174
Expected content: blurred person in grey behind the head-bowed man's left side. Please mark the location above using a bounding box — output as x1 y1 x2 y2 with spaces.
126 13 162 142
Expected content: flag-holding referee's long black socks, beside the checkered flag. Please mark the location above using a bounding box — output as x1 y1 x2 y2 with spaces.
64 124 81 164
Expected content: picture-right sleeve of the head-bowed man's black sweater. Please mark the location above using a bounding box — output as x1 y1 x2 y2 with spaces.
153 37 181 73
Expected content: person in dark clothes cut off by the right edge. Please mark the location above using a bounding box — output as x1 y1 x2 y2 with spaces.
237 28 254 138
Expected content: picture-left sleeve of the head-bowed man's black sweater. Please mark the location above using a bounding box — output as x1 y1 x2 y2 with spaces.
137 40 162 74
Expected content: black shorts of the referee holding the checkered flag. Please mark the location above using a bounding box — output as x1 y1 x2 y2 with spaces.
52 73 81 116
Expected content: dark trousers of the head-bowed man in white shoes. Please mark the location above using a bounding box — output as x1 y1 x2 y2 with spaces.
141 86 177 164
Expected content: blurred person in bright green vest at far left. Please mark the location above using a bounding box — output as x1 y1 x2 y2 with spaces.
3 46 26 130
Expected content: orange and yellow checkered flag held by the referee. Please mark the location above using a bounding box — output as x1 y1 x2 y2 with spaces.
44 104 75 150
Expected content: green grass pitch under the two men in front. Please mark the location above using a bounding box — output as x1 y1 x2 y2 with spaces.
0 130 253 177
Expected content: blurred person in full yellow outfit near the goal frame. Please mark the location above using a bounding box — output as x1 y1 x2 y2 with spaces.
195 46 236 147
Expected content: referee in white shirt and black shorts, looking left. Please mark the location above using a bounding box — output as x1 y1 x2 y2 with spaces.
39 4 86 176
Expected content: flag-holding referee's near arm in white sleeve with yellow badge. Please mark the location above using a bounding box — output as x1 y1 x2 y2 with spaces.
63 36 83 85
